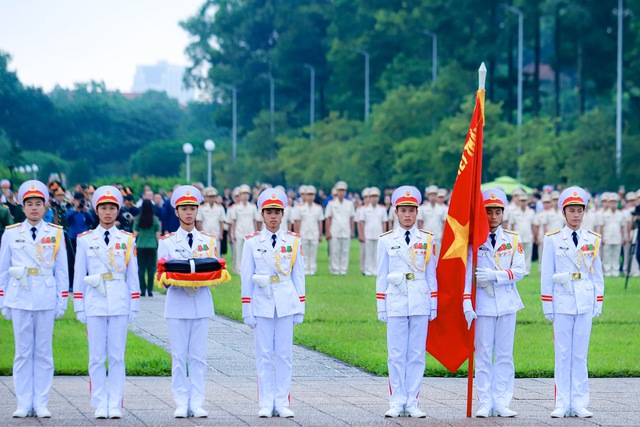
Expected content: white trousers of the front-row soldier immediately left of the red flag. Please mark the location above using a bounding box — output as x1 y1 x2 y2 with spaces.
387 316 429 408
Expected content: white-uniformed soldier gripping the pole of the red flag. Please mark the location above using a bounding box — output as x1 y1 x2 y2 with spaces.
462 188 526 418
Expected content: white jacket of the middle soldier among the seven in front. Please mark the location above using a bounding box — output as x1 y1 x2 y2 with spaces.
240 228 306 318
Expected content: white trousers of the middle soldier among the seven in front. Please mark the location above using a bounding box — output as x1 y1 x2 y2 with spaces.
253 316 293 409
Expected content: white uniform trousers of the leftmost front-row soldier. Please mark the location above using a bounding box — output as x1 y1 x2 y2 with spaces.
11 308 55 410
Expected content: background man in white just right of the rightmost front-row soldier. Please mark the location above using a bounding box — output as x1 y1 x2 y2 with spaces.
602 193 628 277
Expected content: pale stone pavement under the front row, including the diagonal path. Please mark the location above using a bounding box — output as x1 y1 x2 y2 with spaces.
0 294 640 426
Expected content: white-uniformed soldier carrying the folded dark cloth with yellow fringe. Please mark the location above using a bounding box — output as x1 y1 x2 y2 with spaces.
158 185 218 418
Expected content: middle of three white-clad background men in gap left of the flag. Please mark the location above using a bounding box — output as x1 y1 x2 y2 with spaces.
324 181 356 275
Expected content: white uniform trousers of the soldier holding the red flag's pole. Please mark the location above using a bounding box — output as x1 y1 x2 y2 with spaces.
475 313 516 410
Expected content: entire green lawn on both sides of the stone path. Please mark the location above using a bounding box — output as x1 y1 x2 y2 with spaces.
0 241 640 377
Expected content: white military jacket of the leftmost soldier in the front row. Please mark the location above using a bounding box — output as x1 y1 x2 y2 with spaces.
0 221 69 311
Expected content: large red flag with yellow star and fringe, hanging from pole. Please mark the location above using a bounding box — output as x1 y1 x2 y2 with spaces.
427 89 489 372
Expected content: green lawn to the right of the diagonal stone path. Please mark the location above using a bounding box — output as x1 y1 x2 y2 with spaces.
214 241 640 377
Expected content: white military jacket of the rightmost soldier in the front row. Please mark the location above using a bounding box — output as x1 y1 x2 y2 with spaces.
540 227 604 314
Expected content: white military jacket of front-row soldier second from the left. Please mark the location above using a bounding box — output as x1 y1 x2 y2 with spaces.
73 226 140 316
